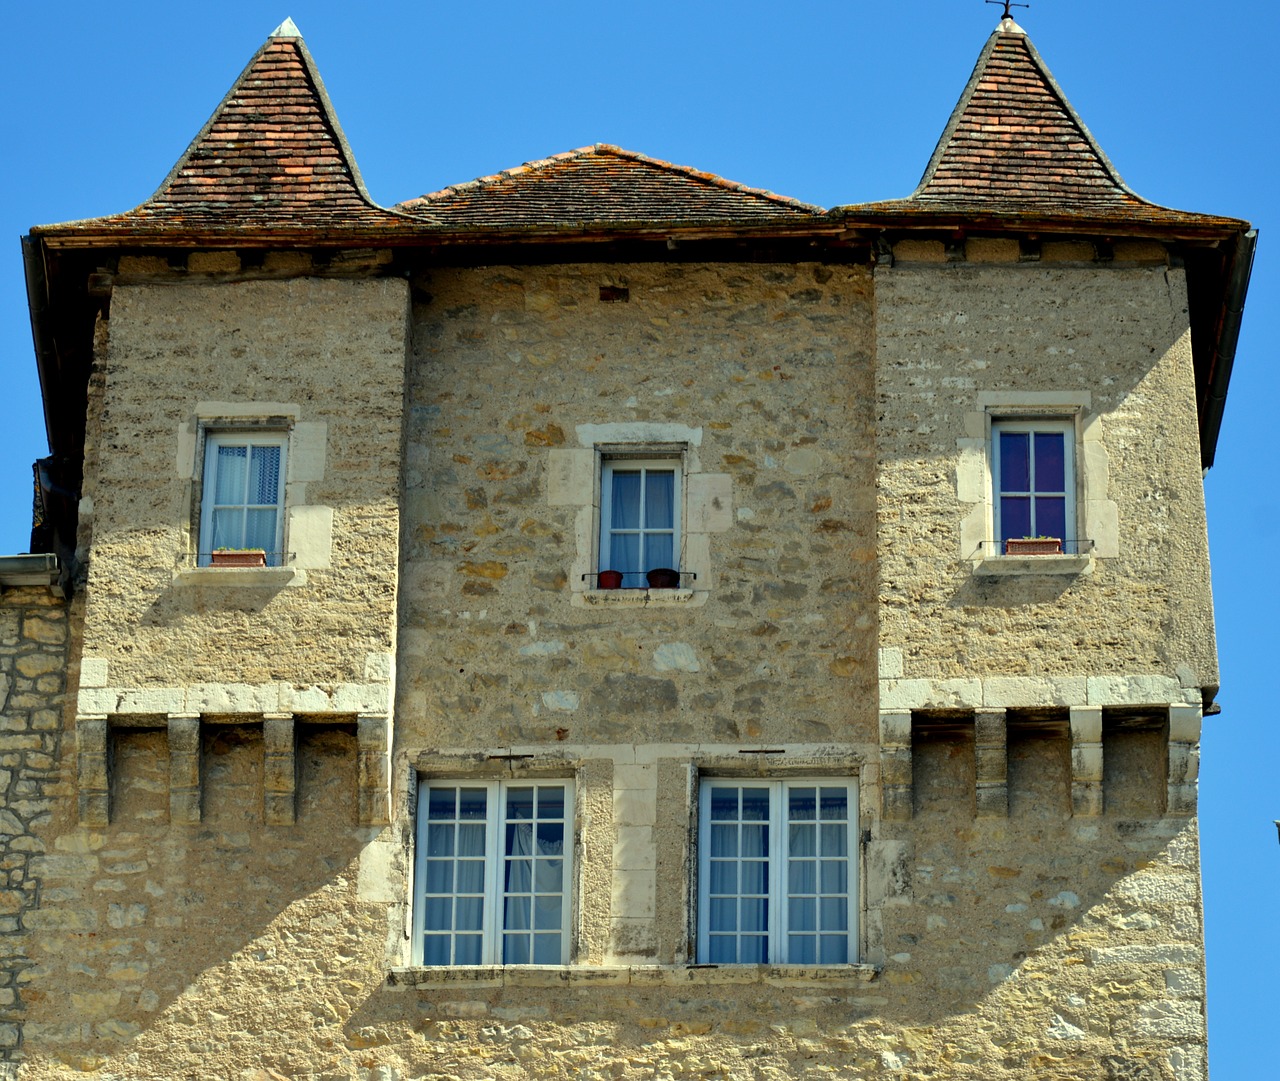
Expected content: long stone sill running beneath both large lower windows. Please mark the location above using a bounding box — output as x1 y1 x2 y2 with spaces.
387 965 881 988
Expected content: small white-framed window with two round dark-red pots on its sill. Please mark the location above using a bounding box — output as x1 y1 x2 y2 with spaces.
596 458 682 590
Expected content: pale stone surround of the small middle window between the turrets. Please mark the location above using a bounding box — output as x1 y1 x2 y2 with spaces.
547 421 732 608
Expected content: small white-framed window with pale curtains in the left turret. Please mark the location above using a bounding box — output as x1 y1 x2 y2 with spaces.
198 431 288 567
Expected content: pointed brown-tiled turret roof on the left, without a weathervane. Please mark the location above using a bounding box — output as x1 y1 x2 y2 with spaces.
33 20 417 234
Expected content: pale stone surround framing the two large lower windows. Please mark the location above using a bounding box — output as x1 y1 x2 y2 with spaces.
389 745 890 986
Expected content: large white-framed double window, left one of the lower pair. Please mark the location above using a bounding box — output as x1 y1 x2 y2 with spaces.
413 779 573 966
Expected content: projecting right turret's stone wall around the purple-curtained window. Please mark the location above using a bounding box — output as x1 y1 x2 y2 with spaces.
876 249 1217 690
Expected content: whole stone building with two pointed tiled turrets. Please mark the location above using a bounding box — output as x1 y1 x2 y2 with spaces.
0 10 1253 1081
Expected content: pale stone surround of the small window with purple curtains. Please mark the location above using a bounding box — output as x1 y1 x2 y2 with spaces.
956 390 1120 574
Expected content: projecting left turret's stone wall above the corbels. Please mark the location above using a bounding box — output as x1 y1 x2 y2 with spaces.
82 272 407 690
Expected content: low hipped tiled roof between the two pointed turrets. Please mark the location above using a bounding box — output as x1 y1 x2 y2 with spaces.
396 143 822 228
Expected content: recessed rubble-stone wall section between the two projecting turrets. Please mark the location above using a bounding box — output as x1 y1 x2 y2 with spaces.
398 265 876 750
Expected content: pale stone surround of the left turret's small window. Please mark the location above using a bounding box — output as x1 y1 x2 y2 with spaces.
174 402 333 586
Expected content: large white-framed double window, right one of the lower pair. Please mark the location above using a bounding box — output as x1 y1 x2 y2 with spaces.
698 778 858 965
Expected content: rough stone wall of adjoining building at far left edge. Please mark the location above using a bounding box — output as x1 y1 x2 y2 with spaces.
0 587 74 1077
